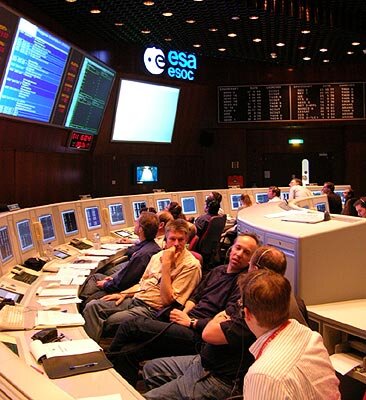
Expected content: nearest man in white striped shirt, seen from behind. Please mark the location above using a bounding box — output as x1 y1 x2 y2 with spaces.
239 269 341 400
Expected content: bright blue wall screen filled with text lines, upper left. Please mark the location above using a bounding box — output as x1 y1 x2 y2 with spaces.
0 18 70 122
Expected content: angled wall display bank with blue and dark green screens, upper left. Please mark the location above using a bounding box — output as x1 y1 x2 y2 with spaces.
0 6 115 135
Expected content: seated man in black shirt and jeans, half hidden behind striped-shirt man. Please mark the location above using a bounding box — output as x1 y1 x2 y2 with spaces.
143 246 305 400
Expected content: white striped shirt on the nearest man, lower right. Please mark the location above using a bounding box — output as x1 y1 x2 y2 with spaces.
244 320 341 400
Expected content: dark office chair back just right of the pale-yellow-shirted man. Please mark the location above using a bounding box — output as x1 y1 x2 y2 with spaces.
196 215 226 270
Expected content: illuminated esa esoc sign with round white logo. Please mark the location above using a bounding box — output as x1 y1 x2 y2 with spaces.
144 47 197 81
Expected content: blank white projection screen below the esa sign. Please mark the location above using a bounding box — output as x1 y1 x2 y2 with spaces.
112 79 179 143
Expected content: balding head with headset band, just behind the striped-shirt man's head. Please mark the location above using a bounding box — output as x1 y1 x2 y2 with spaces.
249 246 287 275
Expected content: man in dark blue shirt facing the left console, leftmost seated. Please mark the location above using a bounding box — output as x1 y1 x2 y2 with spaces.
80 212 161 303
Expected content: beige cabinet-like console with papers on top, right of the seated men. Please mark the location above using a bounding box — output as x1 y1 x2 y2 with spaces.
238 203 366 305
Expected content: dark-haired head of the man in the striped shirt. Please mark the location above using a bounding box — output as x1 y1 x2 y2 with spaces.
238 269 291 334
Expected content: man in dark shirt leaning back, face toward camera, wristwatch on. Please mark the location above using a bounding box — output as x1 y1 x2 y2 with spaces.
109 234 258 385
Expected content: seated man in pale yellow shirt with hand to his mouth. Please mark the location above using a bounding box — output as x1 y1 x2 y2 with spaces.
83 219 201 341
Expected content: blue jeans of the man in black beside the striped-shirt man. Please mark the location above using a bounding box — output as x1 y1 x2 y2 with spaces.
143 355 233 400
